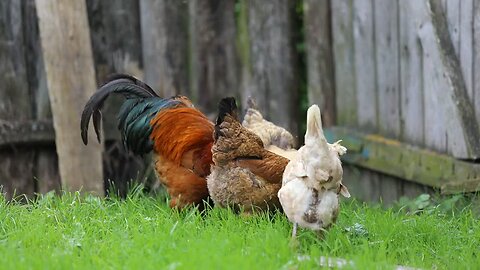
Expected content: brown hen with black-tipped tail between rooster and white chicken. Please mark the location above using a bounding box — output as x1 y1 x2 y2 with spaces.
207 98 289 214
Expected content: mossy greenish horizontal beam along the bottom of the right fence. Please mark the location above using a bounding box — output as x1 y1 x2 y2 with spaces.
325 128 480 188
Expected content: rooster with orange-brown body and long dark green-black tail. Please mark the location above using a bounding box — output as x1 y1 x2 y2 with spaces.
81 74 214 208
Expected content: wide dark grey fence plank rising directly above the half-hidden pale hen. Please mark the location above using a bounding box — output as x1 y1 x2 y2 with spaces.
241 0 298 134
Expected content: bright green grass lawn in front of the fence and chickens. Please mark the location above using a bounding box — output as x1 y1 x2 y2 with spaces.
0 191 480 269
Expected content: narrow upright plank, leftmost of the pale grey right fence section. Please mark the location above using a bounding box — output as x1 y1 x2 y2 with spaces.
331 0 357 126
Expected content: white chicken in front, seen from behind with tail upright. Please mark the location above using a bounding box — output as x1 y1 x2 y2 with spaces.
278 105 350 237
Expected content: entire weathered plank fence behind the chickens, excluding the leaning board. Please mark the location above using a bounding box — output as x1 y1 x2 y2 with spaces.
0 0 480 201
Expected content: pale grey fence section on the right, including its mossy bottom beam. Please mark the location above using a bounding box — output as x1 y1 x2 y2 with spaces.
331 0 480 201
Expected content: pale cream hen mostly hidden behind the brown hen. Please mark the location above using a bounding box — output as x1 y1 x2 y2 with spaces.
242 97 295 150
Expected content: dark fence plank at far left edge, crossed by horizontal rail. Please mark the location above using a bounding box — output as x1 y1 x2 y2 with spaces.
0 1 34 198
